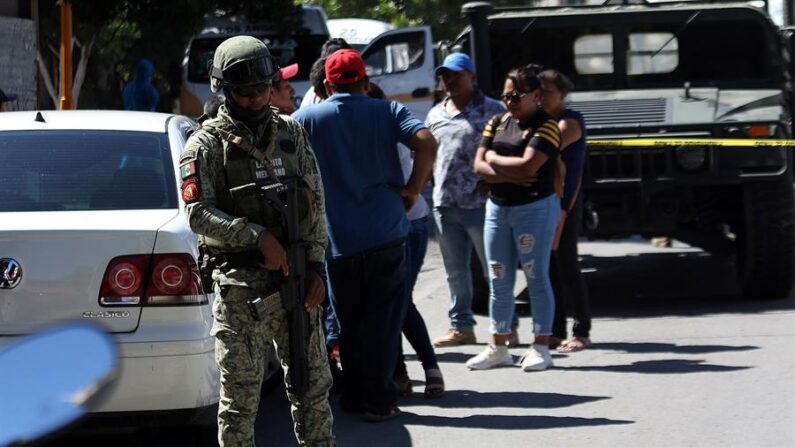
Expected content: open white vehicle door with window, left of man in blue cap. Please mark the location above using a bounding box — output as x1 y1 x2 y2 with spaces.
362 26 436 120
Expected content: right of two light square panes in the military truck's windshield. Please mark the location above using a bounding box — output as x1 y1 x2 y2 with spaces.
627 33 679 75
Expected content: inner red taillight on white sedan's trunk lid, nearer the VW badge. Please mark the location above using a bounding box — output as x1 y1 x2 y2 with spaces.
99 255 149 306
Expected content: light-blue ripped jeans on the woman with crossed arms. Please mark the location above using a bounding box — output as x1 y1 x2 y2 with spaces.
483 194 560 335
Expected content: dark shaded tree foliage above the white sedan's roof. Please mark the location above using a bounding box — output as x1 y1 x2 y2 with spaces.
39 0 301 111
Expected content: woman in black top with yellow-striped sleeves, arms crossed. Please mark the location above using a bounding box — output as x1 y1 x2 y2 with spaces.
467 66 565 371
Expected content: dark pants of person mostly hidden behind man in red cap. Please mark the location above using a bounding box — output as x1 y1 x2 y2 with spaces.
395 217 439 375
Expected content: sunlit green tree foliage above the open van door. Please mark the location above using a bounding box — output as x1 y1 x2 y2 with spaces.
302 0 528 40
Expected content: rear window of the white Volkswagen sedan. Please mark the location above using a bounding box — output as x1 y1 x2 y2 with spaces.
0 130 178 212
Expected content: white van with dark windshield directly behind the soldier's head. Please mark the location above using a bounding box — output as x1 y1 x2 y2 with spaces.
179 6 329 117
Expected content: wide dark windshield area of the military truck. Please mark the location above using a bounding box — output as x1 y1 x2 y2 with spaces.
488 8 782 92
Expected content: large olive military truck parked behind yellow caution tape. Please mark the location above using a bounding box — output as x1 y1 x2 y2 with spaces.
460 0 795 304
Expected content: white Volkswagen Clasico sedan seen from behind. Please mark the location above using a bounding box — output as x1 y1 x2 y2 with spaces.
0 111 280 440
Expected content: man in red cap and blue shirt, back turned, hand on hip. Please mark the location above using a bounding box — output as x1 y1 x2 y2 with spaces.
293 49 436 422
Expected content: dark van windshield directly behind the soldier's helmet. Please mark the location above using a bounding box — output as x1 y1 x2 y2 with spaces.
188 34 326 83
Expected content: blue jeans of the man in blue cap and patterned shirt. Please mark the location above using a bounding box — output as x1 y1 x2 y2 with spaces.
433 206 487 332
